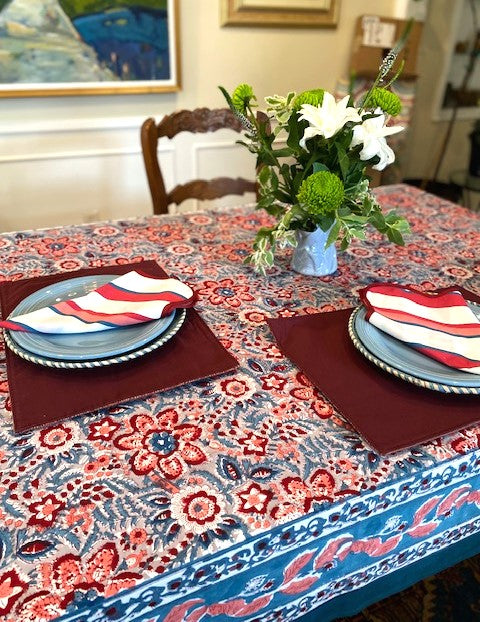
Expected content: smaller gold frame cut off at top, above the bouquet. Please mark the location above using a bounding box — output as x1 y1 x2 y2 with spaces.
220 0 340 28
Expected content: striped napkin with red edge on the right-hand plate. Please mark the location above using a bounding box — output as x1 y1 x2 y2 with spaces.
360 283 480 374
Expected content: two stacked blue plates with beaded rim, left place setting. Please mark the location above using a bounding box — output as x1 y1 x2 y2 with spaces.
4 274 186 369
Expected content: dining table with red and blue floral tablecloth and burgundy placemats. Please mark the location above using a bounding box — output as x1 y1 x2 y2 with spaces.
0 183 480 622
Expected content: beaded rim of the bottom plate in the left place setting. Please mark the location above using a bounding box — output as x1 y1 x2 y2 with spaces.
4 309 187 369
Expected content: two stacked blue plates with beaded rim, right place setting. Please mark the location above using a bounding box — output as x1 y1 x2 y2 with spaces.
348 303 480 395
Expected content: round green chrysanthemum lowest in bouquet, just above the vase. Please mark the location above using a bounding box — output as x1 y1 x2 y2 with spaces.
297 171 345 216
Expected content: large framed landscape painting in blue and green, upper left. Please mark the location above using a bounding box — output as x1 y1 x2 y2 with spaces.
0 0 180 97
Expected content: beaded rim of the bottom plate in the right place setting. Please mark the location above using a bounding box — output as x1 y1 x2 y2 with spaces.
348 308 480 395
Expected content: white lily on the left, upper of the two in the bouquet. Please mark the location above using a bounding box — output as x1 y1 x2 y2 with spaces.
299 91 362 149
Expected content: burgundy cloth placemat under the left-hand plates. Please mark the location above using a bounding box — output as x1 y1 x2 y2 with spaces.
0 261 238 432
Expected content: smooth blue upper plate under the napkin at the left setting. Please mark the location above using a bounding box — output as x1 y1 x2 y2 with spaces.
9 274 175 361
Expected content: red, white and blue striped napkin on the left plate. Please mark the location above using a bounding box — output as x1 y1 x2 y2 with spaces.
0 270 195 334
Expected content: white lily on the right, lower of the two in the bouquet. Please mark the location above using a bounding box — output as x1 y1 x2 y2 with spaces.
350 108 404 171
